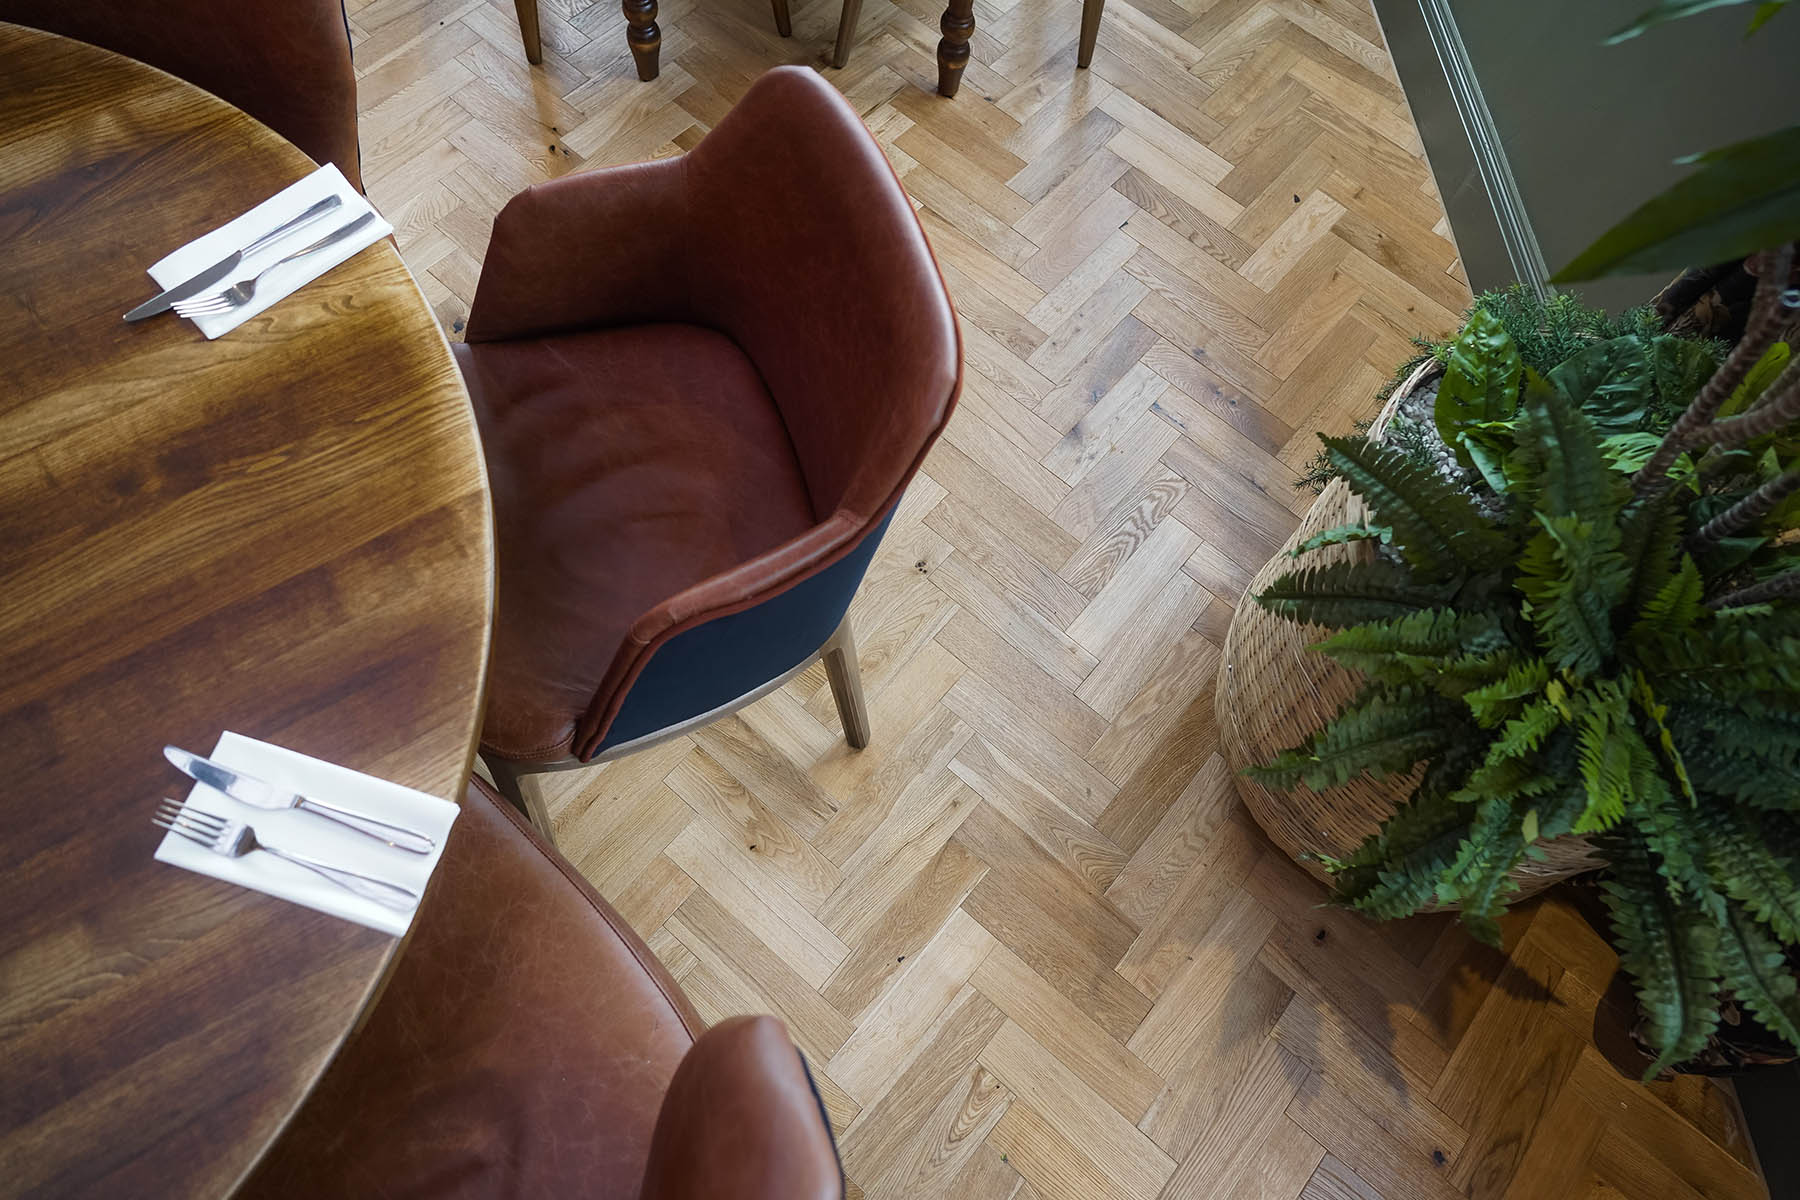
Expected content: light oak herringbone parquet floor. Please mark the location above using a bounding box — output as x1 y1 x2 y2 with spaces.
349 0 1762 1200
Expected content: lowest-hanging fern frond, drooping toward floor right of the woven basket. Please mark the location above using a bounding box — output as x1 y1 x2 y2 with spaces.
1602 835 1719 1079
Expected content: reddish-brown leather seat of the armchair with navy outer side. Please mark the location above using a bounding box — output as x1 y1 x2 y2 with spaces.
455 324 817 757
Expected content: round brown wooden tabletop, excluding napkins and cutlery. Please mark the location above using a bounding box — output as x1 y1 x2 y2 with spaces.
0 23 493 1196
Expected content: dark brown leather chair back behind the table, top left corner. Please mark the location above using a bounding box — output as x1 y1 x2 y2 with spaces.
0 0 362 191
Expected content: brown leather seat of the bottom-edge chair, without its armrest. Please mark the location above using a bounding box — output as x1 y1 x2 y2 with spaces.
238 781 702 1200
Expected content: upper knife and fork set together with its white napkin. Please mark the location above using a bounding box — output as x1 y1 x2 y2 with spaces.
124 164 394 340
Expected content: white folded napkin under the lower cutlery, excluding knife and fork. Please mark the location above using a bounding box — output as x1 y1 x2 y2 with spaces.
157 730 461 937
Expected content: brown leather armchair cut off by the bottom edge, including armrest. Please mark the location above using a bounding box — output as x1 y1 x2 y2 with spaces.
236 781 844 1200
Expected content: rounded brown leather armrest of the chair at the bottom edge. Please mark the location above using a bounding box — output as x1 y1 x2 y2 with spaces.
639 1016 844 1200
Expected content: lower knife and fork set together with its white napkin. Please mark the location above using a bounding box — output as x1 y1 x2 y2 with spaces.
153 732 457 937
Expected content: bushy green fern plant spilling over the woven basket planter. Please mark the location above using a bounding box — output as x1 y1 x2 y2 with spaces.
1249 246 1800 1074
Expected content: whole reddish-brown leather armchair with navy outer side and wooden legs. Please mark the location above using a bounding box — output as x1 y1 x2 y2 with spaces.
455 67 961 820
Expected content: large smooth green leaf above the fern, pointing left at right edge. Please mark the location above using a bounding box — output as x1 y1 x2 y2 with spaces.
1550 126 1800 282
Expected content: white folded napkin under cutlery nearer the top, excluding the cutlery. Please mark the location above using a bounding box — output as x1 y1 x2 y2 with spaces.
149 162 394 340
